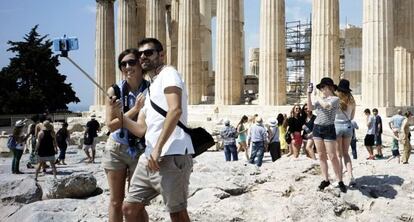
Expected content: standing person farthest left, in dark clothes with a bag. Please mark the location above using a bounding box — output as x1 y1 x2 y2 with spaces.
7 120 28 174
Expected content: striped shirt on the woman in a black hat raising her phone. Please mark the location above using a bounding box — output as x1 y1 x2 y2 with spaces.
313 96 339 126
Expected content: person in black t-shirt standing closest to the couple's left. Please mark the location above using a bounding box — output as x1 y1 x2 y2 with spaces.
83 114 101 163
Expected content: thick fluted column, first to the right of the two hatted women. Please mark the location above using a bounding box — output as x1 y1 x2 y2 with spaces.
362 0 394 107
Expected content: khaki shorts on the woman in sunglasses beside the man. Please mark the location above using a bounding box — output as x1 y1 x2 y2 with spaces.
102 137 138 174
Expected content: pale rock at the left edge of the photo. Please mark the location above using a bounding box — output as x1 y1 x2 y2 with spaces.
0 175 42 204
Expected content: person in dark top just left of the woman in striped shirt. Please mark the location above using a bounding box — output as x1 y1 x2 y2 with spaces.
302 103 316 160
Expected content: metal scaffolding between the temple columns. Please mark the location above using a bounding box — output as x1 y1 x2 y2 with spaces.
285 18 312 103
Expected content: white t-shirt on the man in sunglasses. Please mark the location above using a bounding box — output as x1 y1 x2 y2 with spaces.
143 66 194 157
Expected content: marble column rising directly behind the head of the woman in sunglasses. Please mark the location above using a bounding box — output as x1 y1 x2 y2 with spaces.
116 0 138 81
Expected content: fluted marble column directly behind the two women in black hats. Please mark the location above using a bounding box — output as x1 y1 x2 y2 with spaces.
311 0 340 83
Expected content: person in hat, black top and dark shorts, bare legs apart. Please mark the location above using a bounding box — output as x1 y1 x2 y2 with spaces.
35 120 57 181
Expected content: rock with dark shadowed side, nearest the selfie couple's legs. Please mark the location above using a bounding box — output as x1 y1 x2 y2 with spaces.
45 173 97 199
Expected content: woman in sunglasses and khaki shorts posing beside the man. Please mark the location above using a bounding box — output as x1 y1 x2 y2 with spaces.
102 49 149 221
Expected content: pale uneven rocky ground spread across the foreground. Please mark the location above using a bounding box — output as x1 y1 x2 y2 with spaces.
0 138 414 222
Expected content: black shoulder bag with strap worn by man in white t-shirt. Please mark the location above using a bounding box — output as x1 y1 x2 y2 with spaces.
150 99 216 158
